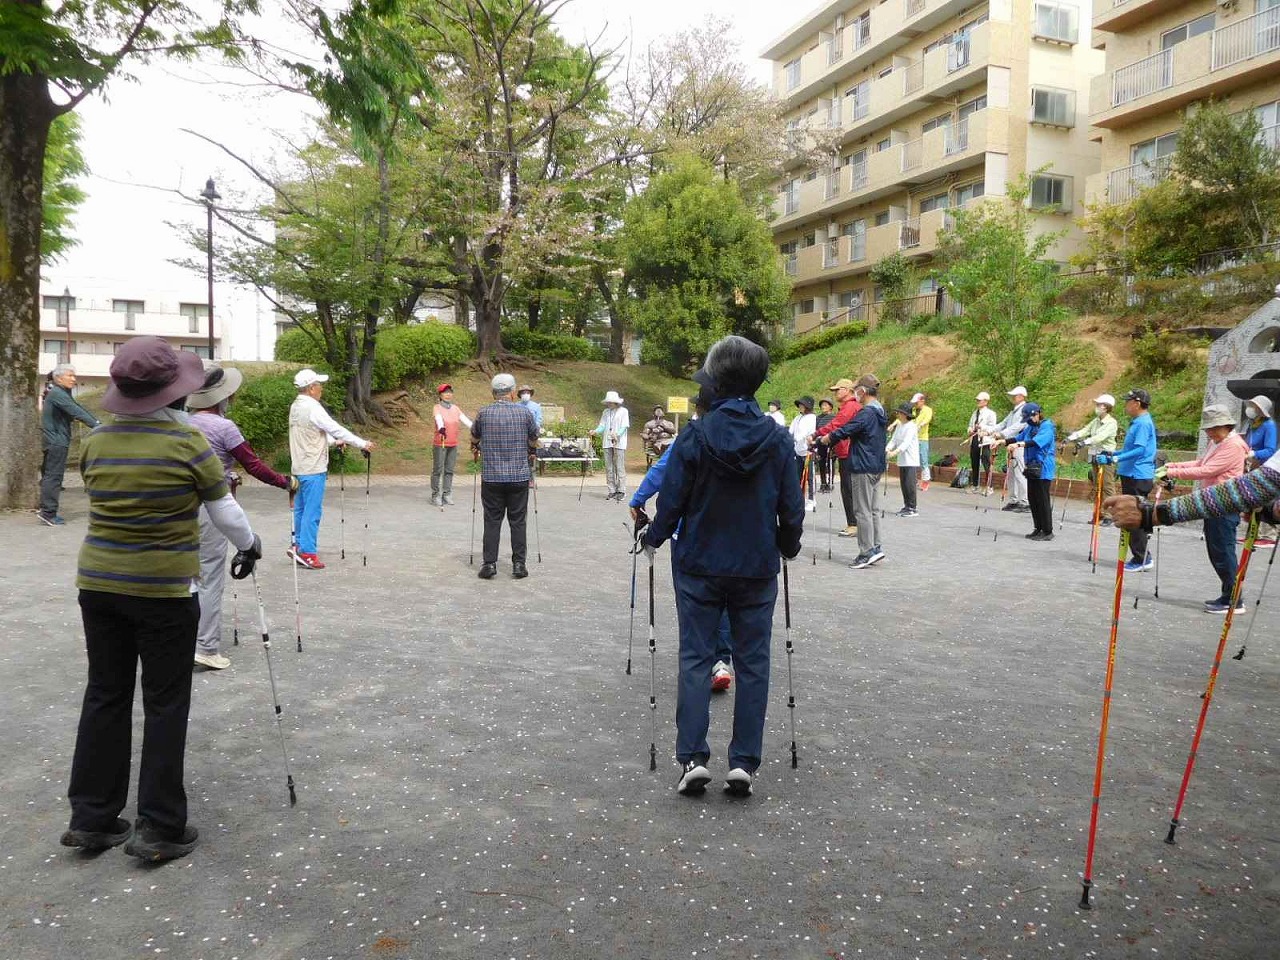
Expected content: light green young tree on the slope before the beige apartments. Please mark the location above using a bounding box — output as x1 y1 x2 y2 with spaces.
937 175 1066 393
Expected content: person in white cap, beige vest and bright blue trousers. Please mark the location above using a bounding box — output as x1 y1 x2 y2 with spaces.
289 369 374 570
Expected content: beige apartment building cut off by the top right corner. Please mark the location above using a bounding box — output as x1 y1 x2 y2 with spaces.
1087 0 1280 204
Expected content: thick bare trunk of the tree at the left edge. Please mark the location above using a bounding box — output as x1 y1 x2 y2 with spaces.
0 73 55 509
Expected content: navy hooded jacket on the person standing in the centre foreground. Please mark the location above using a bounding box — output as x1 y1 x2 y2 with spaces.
645 397 804 580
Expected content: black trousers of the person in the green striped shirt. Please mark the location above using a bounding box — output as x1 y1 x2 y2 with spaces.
68 590 200 836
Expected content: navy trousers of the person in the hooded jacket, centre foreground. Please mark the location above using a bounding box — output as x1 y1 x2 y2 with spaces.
676 573 778 773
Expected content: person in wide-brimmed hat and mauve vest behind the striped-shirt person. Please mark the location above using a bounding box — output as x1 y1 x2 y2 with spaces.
187 366 298 669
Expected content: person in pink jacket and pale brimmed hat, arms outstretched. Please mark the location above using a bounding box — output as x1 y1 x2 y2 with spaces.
1156 401 1256 613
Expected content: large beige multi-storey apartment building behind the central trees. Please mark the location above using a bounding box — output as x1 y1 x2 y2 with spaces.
763 0 1105 333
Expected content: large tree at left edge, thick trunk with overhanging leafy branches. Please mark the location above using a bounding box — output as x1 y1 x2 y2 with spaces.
0 0 257 508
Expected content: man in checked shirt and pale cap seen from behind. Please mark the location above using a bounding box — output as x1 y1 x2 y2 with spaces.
471 374 538 580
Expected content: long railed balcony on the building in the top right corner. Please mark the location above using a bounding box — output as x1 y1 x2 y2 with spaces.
1089 12 1280 129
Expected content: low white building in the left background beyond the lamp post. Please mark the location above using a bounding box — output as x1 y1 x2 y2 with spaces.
40 282 223 385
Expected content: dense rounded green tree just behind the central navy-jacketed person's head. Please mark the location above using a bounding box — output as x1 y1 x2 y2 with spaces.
621 156 791 372
